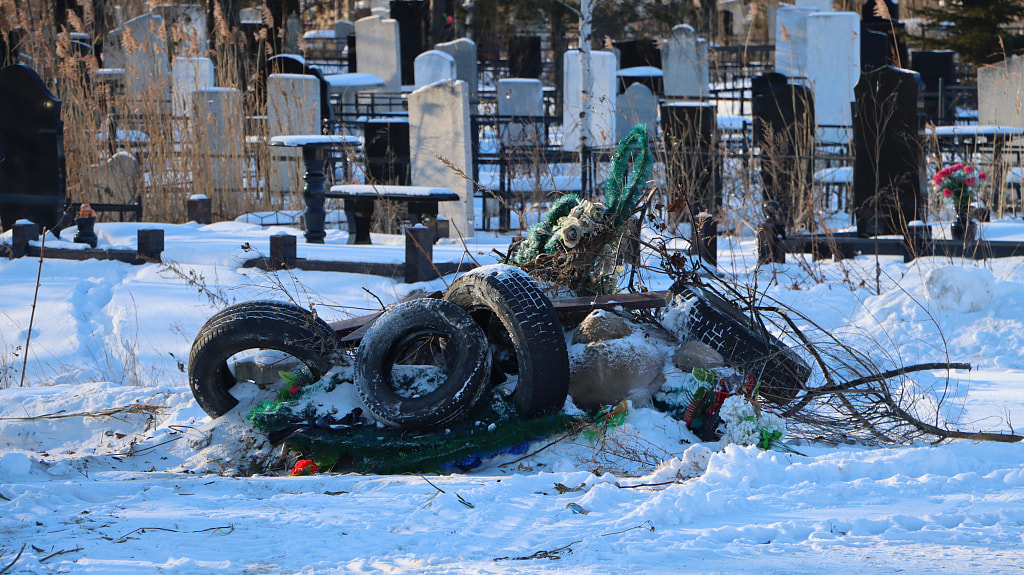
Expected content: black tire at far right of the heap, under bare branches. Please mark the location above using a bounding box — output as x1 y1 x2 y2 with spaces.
670 282 811 405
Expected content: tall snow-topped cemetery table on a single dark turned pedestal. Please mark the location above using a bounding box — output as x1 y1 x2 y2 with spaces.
269 134 369 244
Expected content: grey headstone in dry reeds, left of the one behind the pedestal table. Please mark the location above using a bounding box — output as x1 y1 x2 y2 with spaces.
189 87 245 191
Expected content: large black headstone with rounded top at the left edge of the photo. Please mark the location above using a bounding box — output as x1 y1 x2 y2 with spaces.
0 64 66 230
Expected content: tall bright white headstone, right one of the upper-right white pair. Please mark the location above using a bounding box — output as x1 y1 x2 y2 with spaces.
806 12 860 144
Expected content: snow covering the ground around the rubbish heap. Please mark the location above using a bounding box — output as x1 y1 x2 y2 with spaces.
0 220 1024 574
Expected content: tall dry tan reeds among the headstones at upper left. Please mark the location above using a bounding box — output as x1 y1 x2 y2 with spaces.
0 0 315 223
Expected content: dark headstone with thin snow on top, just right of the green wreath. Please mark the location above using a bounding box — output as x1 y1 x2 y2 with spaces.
662 102 722 219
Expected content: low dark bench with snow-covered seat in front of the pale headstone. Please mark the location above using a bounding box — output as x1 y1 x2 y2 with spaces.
327 184 459 244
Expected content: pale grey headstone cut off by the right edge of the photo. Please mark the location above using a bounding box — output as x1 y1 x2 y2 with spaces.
978 55 1024 128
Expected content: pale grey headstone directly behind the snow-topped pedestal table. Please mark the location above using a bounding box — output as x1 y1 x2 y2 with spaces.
266 74 321 192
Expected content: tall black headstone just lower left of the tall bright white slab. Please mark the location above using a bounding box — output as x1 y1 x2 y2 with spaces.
752 74 815 227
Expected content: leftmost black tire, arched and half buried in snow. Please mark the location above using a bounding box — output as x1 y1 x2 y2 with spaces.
188 301 341 418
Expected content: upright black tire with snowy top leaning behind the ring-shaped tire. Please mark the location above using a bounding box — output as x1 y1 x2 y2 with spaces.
444 265 569 417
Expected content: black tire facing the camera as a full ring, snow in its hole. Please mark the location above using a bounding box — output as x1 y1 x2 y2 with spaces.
355 298 490 430
